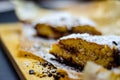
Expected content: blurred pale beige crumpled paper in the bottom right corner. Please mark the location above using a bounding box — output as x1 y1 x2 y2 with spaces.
83 62 120 80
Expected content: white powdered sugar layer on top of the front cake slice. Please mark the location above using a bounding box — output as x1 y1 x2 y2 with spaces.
60 33 120 50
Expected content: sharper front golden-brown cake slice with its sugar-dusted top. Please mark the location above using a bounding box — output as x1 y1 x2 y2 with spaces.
50 33 120 68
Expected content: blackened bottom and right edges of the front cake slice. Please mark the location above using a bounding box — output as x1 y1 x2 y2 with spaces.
51 48 120 72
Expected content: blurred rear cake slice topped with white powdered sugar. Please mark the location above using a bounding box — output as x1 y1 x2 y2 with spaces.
34 13 101 39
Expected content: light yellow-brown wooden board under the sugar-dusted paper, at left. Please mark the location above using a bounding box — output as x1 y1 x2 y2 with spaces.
0 23 71 80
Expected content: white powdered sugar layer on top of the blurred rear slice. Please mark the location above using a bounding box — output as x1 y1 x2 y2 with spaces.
34 12 96 29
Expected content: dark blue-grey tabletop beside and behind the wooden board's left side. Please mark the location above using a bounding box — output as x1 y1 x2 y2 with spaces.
0 10 20 80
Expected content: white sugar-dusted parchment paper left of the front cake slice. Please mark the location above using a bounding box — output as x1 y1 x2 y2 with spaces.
21 26 81 79
